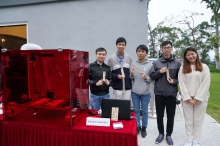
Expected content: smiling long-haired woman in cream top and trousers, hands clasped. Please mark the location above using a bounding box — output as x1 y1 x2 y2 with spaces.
178 47 210 146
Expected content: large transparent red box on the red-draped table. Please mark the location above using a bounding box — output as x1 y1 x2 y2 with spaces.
0 49 89 127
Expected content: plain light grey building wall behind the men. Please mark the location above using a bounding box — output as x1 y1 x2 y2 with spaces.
0 0 148 62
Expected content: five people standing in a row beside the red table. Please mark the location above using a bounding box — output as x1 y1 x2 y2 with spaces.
88 37 210 146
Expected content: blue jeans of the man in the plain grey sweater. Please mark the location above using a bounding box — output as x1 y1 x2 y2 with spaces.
131 92 150 127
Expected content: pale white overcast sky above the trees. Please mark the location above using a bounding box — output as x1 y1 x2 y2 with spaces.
148 0 214 59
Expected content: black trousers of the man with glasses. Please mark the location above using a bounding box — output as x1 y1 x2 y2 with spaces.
155 95 176 136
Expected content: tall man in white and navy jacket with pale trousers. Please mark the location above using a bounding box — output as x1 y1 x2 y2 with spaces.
107 37 132 100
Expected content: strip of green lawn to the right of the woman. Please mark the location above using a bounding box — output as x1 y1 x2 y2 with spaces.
207 72 220 123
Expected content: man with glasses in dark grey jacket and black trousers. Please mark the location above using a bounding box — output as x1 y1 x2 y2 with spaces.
150 41 181 146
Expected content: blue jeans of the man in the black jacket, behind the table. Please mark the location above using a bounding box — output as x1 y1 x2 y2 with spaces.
89 93 110 110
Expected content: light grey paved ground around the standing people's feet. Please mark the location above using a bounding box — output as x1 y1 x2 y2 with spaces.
138 106 220 146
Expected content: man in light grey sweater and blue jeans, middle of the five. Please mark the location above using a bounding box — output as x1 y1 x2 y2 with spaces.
130 45 152 138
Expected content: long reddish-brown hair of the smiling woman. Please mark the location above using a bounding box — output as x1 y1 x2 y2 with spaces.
182 47 203 73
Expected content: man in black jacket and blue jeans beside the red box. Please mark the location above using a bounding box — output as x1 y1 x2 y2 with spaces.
89 48 112 110
